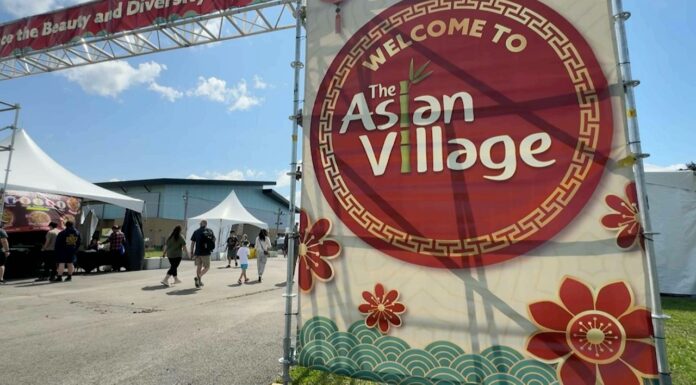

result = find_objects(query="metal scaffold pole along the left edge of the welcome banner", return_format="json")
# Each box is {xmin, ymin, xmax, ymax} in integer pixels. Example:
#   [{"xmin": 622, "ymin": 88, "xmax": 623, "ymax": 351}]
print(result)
[{"xmin": 280, "ymin": 0, "xmax": 304, "ymax": 385}]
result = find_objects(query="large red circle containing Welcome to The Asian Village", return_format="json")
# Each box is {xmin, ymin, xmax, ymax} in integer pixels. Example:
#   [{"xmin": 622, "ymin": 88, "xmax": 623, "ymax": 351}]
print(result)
[{"xmin": 310, "ymin": 0, "xmax": 613, "ymax": 268}]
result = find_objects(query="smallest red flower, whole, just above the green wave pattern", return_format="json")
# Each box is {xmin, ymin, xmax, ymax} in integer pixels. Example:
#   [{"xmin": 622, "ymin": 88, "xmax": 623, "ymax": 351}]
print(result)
[{"xmin": 358, "ymin": 283, "xmax": 406, "ymax": 334}]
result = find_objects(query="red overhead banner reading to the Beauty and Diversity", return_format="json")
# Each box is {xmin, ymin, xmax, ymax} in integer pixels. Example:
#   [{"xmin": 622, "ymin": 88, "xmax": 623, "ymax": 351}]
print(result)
[{"xmin": 0, "ymin": 0, "xmax": 258, "ymax": 58}]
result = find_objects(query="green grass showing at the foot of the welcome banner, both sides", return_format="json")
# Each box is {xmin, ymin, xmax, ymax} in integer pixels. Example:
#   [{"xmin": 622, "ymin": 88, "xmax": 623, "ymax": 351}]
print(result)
[{"xmin": 291, "ymin": 297, "xmax": 696, "ymax": 385}]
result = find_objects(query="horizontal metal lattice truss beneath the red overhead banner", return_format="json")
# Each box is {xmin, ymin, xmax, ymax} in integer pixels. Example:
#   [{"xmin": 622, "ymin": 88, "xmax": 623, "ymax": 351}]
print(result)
[{"xmin": 0, "ymin": 0, "xmax": 297, "ymax": 81}]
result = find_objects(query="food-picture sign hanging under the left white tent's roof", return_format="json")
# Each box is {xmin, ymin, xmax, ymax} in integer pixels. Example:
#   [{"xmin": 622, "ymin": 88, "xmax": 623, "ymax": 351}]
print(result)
[{"xmin": 2, "ymin": 191, "xmax": 82, "ymax": 233}]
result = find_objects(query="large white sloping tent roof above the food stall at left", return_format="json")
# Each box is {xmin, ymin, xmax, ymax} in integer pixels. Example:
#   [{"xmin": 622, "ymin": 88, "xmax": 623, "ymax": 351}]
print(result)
[{"xmin": 0, "ymin": 129, "xmax": 144, "ymax": 212}]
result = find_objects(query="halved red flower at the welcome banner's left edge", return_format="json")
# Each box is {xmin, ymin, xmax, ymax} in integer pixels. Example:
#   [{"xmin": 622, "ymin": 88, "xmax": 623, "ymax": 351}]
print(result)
[{"xmin": 297, "ymin": 211, "xmax": 341, "ymax": 292}]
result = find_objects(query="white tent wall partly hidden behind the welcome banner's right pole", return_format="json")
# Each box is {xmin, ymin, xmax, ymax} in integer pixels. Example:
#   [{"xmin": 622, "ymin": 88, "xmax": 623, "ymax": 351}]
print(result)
[{"xmin": 645, "ymin": 171, "xmax": 696, "ymax": 295}]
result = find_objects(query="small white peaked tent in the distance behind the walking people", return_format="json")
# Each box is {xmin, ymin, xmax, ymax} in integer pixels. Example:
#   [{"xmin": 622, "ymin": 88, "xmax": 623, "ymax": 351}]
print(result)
[{"xmin": 186, "ymin": 191, "xmax": 268, "ymax": 252}]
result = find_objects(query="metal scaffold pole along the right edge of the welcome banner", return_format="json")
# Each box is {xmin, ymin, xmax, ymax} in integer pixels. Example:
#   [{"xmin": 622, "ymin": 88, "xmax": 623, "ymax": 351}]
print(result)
[{"xmin": 612, "ymin": 0, "xmax": 672, "ymax": 385}]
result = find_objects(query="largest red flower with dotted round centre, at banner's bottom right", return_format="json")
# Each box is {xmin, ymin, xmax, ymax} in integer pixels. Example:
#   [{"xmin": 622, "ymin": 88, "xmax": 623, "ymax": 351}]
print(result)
[{"xmin": 527, "ymin": 277, "xmax": 657, "ymax": 385}]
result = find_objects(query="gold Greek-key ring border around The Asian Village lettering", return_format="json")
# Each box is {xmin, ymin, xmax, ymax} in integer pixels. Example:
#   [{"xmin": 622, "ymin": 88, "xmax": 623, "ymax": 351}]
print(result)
[{"xmin": 318, "ymin": 0, "xmax": 600, "ymax": 257}]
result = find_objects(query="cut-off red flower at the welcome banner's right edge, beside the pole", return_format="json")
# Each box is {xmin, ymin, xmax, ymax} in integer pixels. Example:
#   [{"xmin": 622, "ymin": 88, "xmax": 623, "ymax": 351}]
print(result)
[{"xmin": 602, "ymin": 182, "xmax": 645, "ymax": 249}]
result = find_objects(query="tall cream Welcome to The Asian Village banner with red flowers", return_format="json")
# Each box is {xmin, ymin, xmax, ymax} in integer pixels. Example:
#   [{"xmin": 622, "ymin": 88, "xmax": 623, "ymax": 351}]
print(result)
[{"xmin": 297, "ymin": 0, "xmax": 657, "ymax": 385}]
